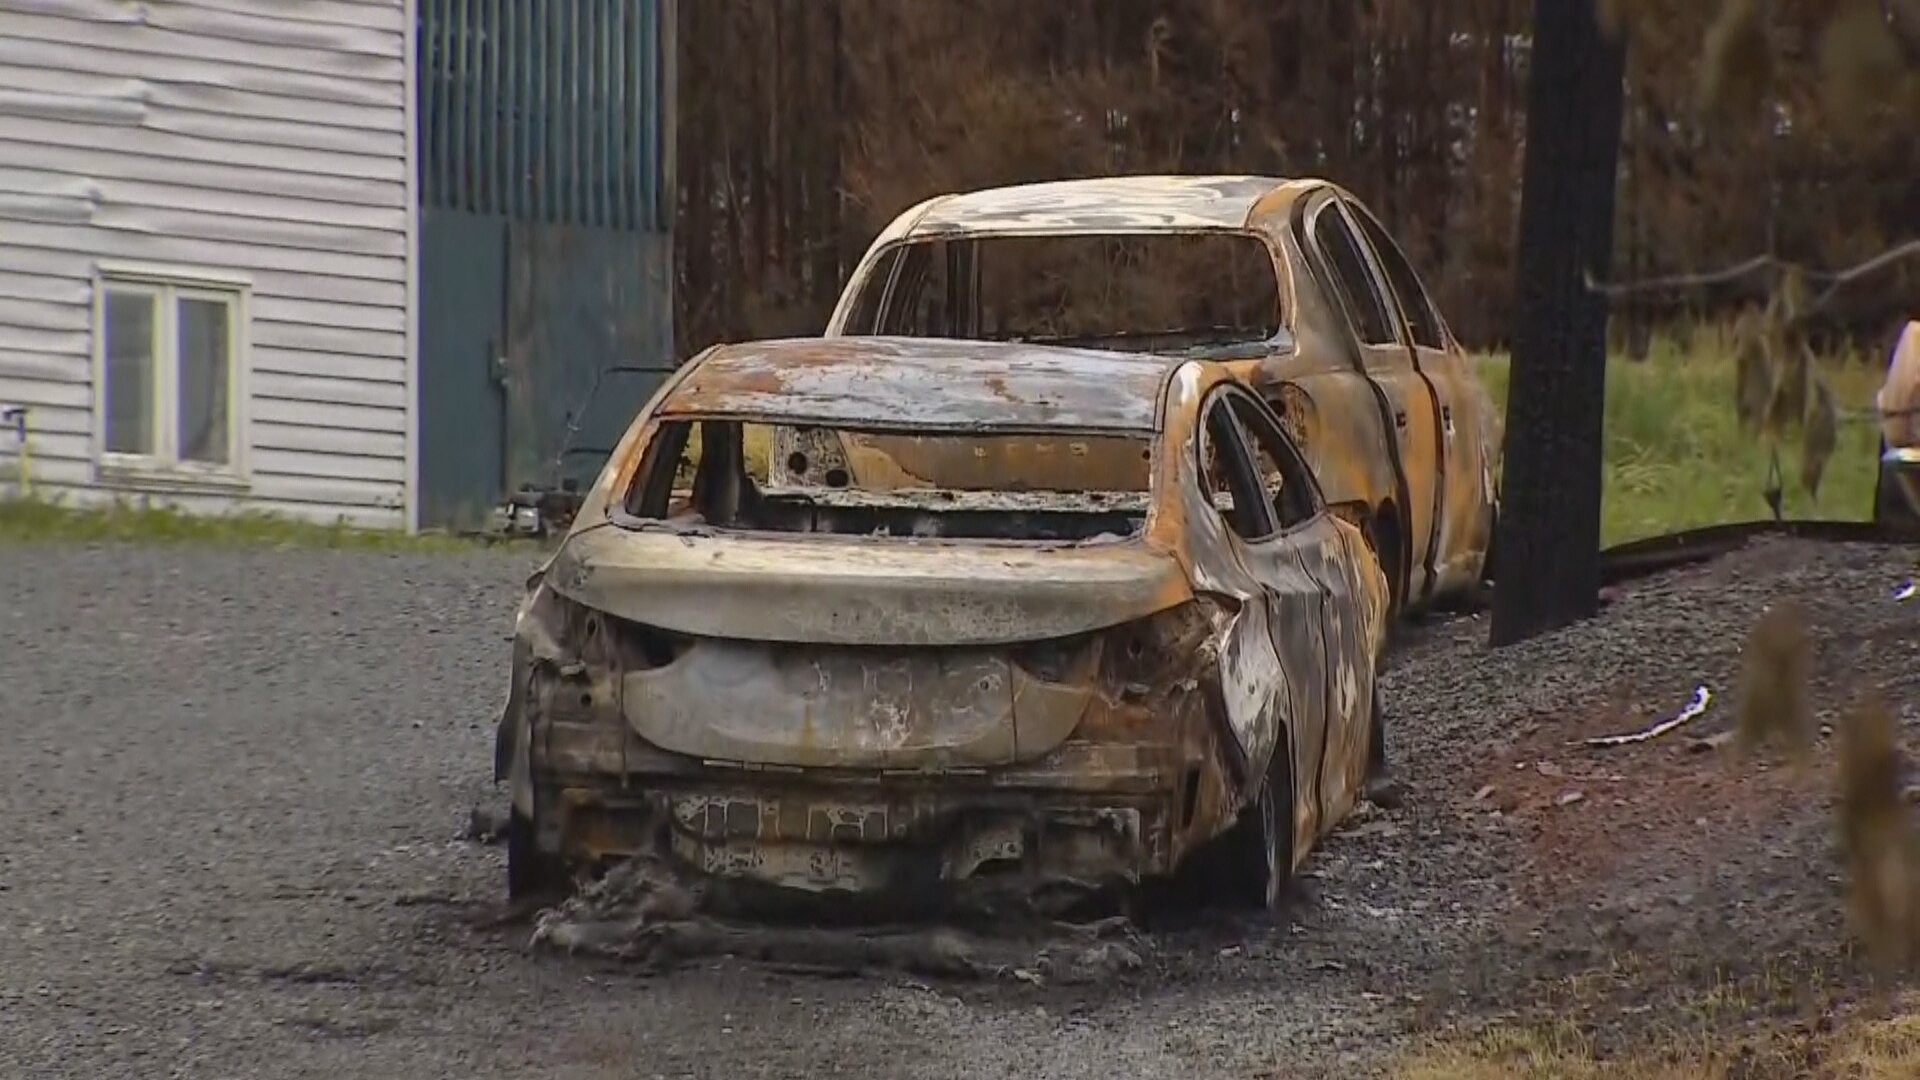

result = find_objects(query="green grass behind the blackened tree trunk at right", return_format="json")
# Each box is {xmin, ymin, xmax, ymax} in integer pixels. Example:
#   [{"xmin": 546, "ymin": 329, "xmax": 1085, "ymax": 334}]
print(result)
[{"xmin": 1478, "ymin": 332, "xmax": 1884, "ymax": 544}]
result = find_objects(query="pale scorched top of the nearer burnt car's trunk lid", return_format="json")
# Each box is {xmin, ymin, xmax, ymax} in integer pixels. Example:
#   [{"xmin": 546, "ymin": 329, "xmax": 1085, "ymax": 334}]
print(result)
[{"xmin": 545, "ymin": 525, "xmax": 1192, "ymax": 646}]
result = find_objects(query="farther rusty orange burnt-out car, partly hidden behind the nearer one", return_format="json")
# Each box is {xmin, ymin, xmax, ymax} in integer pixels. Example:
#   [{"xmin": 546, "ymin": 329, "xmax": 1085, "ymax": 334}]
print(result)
[{"xmin": 770, "ymin": 177, "xmax": 1500, "ymax": 609}]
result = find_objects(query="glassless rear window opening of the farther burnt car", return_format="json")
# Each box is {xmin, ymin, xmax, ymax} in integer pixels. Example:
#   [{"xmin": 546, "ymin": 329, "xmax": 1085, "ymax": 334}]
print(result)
[{"xmin": 845, "ymin": 233, "xmax": 1284, "ymax": 356}]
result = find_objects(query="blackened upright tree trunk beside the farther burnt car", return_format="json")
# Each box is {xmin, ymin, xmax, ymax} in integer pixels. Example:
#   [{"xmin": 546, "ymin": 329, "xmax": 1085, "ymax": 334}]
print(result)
[{"xmin": 1492, "ymin": 0, "xmax": 1626, "ymax": 646}]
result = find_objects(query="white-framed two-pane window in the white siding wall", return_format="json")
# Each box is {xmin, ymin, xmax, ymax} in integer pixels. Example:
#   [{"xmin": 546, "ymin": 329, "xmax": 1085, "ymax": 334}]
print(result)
[{"xmin": 94, "ymin": 265, "xmax": 250, "ymax": 486}]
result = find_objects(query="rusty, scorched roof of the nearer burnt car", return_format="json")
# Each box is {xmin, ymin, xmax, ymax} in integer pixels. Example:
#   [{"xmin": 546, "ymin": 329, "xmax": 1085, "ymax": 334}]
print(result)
[{"xmin": 657, "ymin": 336, "xmax": 1181, "ymax": 434}]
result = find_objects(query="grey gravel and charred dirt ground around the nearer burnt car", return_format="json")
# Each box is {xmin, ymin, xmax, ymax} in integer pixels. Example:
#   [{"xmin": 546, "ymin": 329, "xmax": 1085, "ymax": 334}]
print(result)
[{"xmin": 0, "ymin": 544, "xmax": 1920, "ymax": 1078}]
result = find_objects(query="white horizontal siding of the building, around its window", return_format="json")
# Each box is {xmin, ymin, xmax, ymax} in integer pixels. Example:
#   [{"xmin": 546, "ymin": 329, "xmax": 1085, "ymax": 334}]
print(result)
[{"xmin": 0, "ymin": 0, "xmax": 415, "ymax": 527}]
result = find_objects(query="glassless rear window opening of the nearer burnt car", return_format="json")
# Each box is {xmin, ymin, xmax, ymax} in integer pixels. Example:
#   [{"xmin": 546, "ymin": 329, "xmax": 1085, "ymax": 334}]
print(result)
[{"xmin": 626, "ymin": 419, "xmax": 1152, "ymax": 544}]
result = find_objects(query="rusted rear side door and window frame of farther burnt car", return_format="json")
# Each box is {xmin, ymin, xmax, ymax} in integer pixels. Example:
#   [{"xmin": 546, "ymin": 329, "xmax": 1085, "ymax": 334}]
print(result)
[{"xmin": 1296, "ymin": 184, "xmax": 1446, "ymax": 603}]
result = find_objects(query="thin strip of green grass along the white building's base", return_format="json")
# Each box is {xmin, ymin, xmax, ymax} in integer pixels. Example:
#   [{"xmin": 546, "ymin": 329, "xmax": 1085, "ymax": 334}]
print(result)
[{"xmin": 0, "ymin": 498, "xmax": 495, "ymax": 552}]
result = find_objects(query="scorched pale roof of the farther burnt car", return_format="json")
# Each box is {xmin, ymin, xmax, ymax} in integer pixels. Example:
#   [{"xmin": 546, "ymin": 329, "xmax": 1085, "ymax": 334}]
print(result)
[{"xmin": 908, "ymin": 175, "xmax": 1292, "ymax": 236}]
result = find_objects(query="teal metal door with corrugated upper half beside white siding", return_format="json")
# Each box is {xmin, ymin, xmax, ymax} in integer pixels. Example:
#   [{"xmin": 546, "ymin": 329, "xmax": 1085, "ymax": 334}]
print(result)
[{"xmin": 420, "ymin": 0, "xmax": 674, "ymax": 525}]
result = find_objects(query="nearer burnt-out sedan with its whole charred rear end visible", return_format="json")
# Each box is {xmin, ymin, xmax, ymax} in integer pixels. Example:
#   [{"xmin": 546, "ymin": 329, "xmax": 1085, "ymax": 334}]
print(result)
[{"xmin": 495, "ymin": 336, "xmax": 1388, "ymax": 903}]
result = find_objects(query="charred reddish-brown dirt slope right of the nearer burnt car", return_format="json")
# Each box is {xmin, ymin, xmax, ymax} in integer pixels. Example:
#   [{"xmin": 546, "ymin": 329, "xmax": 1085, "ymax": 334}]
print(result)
[{"xmin": 1404, "ymin": 542, "xmax": 1920, "ymax": 1074}]
